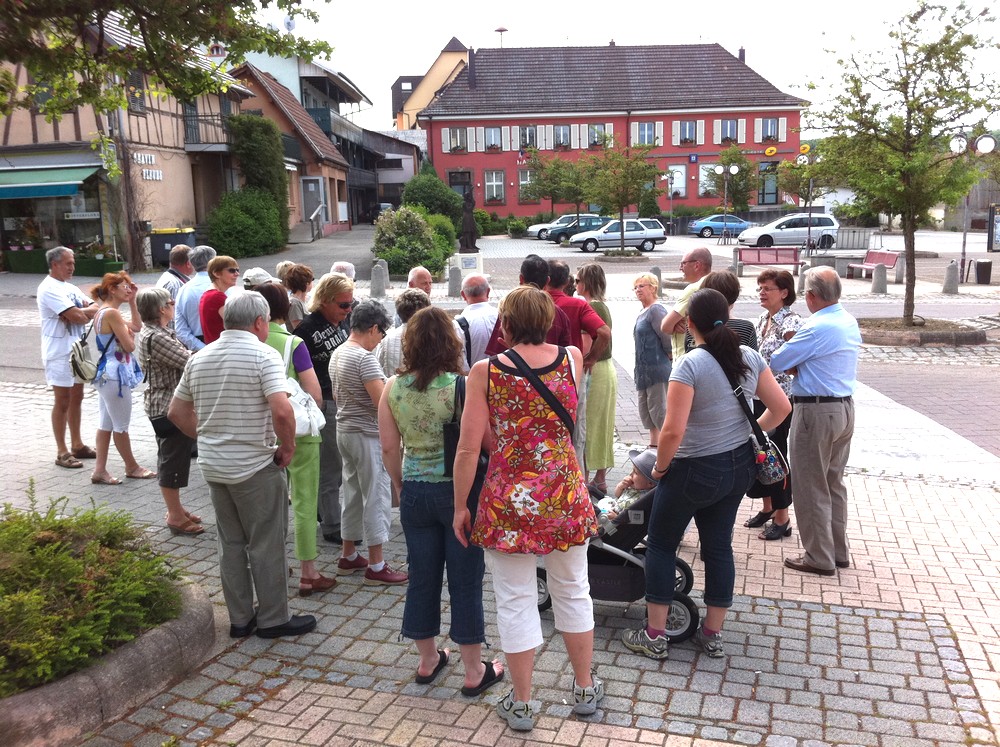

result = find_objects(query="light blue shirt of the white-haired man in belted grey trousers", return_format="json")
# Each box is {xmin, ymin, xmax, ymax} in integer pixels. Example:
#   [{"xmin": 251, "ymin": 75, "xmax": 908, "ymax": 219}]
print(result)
[{"xmin": 771, "ymin": 303, "xmax": 861, "ymax": 397}]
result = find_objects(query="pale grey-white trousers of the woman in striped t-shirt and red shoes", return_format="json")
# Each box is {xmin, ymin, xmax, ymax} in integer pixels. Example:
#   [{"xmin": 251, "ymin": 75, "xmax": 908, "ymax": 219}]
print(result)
[{"xmin": 337, "ymin": 429, "xmax": 392, "ymax": 546}]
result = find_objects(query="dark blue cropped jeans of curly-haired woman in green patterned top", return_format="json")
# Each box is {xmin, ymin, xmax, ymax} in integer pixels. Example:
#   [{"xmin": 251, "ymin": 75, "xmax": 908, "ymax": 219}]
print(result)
[{"xmin": 399, "ymin": 480, "xmax": 486, "ymax": 646}]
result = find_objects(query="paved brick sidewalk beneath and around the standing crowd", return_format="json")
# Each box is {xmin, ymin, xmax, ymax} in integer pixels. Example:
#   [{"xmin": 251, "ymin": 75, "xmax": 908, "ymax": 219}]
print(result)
[{"xmin": 0, "ymin": 241, "xmax": 1000, "ymax": 747}]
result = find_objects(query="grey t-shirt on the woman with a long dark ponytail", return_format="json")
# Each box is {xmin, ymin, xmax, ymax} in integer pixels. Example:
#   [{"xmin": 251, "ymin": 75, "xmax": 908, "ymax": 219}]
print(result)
[{"xmin": 670, "ymin": 345, "xmax": 767, "ymax": 459}]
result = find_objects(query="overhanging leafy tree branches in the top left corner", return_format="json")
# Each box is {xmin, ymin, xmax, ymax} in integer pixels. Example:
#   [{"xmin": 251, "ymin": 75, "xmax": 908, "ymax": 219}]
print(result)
[{"xmin": 0, "ymin": 0, "xmax": 332, "ymax": 119}]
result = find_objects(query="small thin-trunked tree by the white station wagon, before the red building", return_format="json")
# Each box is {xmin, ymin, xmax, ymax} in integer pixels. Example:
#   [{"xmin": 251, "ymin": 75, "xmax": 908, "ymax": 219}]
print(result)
[{"xmin": 582, "ymin": 138, "xmax": 662, "ymax": 251}]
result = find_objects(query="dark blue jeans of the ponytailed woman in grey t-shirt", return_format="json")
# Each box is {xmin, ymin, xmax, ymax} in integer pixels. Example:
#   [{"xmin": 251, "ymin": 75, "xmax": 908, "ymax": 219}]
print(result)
[{"xmin": 646, "ymin": 442, "xmax": 757, "ymax": 607}]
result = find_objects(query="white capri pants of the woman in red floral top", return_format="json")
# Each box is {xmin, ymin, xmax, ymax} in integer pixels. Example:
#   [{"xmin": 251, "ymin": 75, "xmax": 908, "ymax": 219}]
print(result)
[{"xmin": 486, "ymin": 542, "xmax": 594, "ymax": 654}]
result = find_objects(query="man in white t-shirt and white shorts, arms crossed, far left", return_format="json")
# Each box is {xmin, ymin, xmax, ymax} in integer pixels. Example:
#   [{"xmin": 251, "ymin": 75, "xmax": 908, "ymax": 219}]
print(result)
[{"xmin": 35, "ymin": 246, "xmax": 97, "ymax": 469}]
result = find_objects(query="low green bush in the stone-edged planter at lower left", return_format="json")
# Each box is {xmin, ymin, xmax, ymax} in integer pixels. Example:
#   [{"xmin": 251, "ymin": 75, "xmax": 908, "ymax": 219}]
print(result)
[{"xmin": 0, "ymin": 482, "xmax": 181, "ymax": 697}]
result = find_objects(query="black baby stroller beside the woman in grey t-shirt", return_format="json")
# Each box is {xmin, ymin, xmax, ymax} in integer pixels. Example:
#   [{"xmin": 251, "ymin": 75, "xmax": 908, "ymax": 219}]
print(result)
[{"xmin": 537, "ymin": 487, "xmax": 700, "ymax": 643}]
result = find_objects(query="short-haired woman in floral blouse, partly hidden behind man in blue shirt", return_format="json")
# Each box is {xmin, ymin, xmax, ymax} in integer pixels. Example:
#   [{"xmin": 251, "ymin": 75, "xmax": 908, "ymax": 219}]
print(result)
[{"xmin": 744, "ymin": 269, "xmax": 802, "ymax": 540}]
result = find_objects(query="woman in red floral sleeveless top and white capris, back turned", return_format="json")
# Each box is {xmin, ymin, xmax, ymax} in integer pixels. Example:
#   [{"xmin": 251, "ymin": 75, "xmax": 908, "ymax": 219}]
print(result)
[{"xmin": 454, "ymin": 286, "xmax": 604, "ymax": 731}]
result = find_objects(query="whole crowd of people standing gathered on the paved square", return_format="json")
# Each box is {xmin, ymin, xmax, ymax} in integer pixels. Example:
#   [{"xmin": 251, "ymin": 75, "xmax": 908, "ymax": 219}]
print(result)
[{"xmin": 39, "ymin": 246, "xmax": 860, "ymax": 730}]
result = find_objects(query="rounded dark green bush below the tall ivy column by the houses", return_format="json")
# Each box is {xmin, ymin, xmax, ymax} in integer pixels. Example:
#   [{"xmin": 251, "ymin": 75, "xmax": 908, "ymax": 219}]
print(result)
[{"xmin": 206, "ymin": 187, "xmax": 285, "ymax": 258}]
